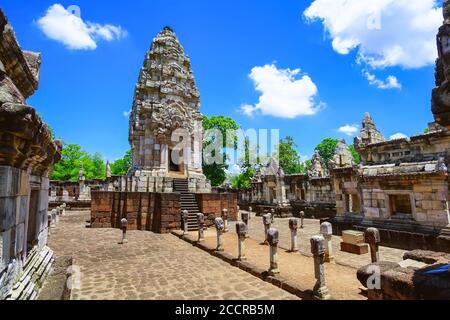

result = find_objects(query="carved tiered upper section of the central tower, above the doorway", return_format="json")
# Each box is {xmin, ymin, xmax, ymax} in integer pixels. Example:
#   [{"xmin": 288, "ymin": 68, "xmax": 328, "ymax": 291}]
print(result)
[{"xmin": 129, "ymin": 27, "xmax": 202, "ymax": 144}]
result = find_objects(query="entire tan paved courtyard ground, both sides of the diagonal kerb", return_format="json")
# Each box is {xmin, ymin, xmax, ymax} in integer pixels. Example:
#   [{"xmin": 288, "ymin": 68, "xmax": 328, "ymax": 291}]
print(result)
[{"xmin": 43, "ymin": 211, "xmax": 404, "ymax": 300}]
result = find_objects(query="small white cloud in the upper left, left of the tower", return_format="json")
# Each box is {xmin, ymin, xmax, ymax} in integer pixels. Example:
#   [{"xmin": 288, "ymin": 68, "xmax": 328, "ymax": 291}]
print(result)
[{"xmin": 37, "ymin": 3, "xmax": 127, "ymax": 50}]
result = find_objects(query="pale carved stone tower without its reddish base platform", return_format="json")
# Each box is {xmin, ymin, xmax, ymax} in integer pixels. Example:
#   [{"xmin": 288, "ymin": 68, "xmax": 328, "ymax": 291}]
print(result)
[{"xmin": 129, "ymin": 27, "xmax": 211, "ymax": 192}]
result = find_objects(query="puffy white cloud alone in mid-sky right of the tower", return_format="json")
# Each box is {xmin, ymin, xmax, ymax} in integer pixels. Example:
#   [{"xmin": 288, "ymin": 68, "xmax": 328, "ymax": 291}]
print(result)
[{"xmin": 241, "ymin": 64, "xmax": 323, "ymax": 119}]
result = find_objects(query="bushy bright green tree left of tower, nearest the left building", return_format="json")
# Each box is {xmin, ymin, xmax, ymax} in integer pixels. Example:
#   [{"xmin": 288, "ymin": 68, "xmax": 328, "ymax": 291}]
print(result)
[{"xmin": 52, "ymin": 144, "xmax": 106, "ymax": 181}]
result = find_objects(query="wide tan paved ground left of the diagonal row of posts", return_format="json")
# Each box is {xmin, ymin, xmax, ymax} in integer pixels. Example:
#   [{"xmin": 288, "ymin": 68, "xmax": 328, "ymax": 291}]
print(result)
[{"xmin": 49, "ymin": 211, "xmax": 297, "ymax": 300}]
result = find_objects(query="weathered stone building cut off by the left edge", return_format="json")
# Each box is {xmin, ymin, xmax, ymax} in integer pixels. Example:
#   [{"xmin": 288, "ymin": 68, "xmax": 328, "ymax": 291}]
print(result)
[{"xmin": 0, "ymin": 10, "xmax": 61, "ymax": 300}]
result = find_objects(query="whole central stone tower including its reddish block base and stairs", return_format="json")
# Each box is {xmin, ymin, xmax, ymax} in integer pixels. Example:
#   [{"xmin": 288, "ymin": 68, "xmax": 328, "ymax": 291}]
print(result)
[{"xmin": 91, "ymin": 27, "xmax": 238, "ymax": 233}]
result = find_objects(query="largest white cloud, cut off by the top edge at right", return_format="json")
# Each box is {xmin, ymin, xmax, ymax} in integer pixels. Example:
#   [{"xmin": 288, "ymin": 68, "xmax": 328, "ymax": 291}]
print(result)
[{"xmin": 304, "ymin": 0, "xmax": 442, "ymax": 68}]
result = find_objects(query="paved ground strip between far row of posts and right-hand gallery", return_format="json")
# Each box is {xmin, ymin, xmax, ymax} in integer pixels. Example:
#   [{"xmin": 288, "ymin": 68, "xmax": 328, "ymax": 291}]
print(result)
[{"xmin": 230, "ymin": 217, "xmax": 406, "ymax": 269}]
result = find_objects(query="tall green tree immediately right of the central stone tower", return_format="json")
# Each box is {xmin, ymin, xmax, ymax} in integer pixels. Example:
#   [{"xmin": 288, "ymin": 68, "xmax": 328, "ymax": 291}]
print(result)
[{"xmin": 203, "ymin": 116, "xmax": 239, "ymax": 186}]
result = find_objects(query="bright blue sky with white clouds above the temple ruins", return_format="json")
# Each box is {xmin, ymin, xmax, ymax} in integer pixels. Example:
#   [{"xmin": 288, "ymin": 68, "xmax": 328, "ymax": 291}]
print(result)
[{"xmin": 1, "ymin": 0, "xmax": 442, "ymax": 160}]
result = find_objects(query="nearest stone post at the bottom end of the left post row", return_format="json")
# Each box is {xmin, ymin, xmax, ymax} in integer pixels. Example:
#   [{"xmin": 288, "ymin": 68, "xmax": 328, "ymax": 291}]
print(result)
[{"xmin": 311, "ymin": 235, "xmax": 330, "ymax": 300}]
